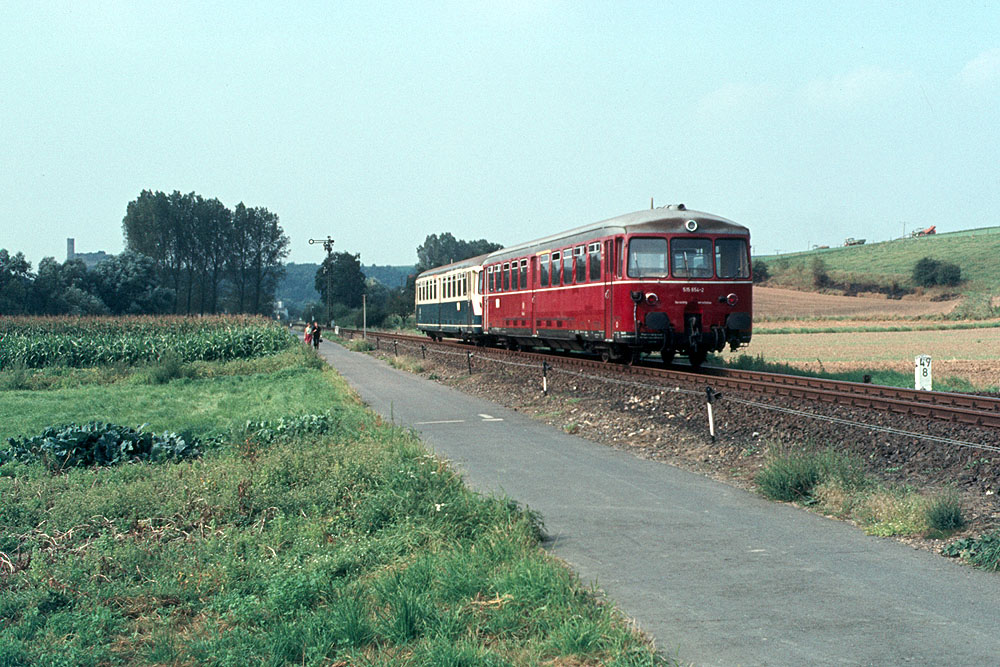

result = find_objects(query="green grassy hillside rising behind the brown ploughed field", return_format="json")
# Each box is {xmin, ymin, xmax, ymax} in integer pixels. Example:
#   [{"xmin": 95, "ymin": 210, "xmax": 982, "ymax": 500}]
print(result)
[{"xmin": 754, "ymin": 227, "xmax": 1000, "ymax": 317}]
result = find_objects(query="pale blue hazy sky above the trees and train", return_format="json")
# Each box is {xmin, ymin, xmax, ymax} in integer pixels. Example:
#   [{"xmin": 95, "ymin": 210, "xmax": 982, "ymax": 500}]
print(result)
[{"xmin": 0, "ymin": 0, "xmax": 1000, "ymax": 268}]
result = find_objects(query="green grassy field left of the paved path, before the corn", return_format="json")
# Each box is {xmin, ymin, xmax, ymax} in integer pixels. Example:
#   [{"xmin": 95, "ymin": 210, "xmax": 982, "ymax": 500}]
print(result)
[{"xmin": 0, "ymin": 320, "xmax": 665, "ymax": 666}]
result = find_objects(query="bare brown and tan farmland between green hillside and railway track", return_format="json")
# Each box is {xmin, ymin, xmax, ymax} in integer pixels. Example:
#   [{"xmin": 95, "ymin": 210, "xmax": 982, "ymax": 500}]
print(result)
[{"xmin": 724, "ymin": 287, "xmax": 1000, "ymax": 389}]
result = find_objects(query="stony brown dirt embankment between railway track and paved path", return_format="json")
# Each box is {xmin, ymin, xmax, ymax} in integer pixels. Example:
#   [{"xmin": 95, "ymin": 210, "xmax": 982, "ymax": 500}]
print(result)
[{"xmin": 373, "ymin": 345, "xmax": 1000, "ymax": 552}]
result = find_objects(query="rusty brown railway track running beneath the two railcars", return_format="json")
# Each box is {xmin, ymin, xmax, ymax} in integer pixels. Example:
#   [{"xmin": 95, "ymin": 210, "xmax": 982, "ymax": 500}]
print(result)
[{"xmin": 341, "ymin": 329, "xmax": 1000, "ymax": 428}]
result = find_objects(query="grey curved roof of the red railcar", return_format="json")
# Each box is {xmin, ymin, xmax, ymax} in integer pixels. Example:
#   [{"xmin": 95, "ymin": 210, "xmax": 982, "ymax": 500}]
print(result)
[{"xmin": 485, "ymin": 206, "xmax": 750, "ymax": 263}]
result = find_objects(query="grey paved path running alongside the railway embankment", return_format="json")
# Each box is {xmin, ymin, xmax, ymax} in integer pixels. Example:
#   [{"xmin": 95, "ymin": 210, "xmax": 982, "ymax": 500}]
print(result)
[{"xmin": 320, "ymin": 342, "xmax": 1000, "ymax": 666}]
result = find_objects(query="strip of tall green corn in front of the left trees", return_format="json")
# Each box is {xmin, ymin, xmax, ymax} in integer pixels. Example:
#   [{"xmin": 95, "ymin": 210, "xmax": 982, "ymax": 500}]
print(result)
[{"xmin": 0, "ymin": 316, "xmax": 295, "ymax": 369}]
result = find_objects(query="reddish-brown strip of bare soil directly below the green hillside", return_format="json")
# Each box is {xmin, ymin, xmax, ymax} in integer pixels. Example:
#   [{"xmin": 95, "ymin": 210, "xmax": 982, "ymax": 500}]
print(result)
[{"xmin": 753, "ymin": 286, "xmax": 959, "ymax": 321}]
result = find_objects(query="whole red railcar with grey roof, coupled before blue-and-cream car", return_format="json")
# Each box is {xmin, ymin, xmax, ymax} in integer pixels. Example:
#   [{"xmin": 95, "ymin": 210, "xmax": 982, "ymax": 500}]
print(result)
[{"xmin": 480, "ymin": 205, "xmax": 753, "ymax": 364}]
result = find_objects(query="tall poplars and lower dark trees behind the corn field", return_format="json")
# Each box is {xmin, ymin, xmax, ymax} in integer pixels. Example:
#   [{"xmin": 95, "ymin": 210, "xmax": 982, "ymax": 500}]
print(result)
[{"xmin": 0, "ymin": 190, "xmax": 289, "ymax": 315}]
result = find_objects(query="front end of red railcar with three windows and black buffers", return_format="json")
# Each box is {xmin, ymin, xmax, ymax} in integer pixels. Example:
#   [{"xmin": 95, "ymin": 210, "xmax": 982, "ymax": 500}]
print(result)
[{"xmin": 613, "ymin": 207, "xmax": 753, "ymax": 365}]
